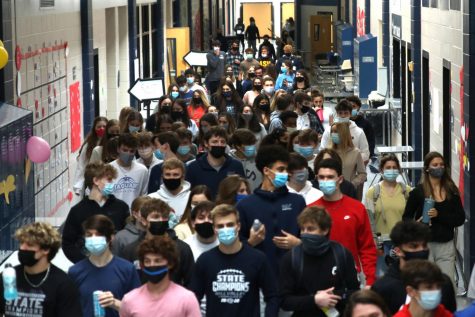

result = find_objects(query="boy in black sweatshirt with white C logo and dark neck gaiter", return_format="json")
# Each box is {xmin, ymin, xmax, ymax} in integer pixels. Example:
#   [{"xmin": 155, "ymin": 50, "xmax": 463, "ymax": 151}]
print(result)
[{"xmin": 279, "ymin": 207, "xmax": 359, "ymax": 317}]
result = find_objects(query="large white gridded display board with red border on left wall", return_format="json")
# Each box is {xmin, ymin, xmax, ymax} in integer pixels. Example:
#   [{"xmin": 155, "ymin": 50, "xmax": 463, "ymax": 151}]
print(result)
[{"xmin": 15, "ymin": 40, "xmax": 72, "ymax": 219}]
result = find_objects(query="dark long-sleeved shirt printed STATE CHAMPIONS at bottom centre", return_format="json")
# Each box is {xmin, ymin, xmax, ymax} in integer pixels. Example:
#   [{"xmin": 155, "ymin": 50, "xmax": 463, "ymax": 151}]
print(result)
[{"xmin": 190, "ymin": 244, "xmax": 279, "ymax": 317}]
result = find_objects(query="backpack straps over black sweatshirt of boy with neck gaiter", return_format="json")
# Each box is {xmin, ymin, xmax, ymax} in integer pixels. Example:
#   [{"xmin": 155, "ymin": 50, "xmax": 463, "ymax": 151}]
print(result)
[{"xmin": 290, "ymin": 241, "xmax": 348, "ymax": 294}]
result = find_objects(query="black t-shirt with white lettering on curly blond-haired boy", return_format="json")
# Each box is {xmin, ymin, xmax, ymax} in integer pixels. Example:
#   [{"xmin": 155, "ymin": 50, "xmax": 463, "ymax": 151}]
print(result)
[{"xmin": 0, "ymin": 264, "xmax": 82, "ymax": 317}]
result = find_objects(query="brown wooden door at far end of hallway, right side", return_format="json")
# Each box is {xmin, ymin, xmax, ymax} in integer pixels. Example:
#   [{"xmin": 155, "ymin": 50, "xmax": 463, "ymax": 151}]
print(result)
[{"xmin": 308, "ymin": 15, "xmax": 332, "ymax": 55}]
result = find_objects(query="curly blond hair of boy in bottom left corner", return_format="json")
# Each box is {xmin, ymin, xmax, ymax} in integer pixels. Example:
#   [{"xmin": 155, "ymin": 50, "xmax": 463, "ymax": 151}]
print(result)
[{"xmin": 15, "ymin": 222, "xmax": 61, "ymax": 261}]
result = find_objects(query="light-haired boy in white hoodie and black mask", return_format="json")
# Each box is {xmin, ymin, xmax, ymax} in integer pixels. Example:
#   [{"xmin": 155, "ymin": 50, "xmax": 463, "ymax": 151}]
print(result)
[{"xmin": 149, "ymin": 158, "xmax": 190, "ymax": 221}]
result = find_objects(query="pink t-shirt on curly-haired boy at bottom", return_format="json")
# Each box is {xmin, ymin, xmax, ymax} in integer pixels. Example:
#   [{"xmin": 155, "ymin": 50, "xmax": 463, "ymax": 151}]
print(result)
[{"xmin": 120, "ymin": 282, "xmax": 201, "ymax": 317}]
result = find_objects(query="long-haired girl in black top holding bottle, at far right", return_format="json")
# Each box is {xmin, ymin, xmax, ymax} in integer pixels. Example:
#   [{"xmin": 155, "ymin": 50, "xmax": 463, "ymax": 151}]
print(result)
[{"xmin": 403, "ymin": 152, "xmax": 465, "ymax": 281}]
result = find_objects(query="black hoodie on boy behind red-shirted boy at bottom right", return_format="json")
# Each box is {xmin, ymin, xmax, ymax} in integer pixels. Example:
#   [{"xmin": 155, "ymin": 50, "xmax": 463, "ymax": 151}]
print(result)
[{"xmin": 371, "ymin": 261, "xmax": 457, "ymax": 314}]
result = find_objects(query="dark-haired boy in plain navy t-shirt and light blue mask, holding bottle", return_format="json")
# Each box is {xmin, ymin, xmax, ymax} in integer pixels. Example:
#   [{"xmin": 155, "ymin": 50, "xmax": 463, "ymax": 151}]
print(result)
[{"xmin": 68, "ymin": 215, "xmax": 140, "ymax": 317}]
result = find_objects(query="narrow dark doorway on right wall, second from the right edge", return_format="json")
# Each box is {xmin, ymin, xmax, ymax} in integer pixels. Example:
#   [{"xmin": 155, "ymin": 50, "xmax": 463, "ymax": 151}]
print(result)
[{"xmin": 422, "ymin": 51, "xmax": 430, "ymax": 155}]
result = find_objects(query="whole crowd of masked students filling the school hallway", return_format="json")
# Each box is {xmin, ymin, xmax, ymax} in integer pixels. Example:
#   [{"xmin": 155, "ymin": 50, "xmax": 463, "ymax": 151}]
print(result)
[{"xmin": 0, "ymin": 34, "xmax": 472, "ymax": 317}]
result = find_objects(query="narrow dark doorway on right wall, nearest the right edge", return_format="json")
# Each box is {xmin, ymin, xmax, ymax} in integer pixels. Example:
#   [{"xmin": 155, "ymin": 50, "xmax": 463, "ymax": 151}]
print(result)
[{"xmin": 442, "ymin": 59, "xmax": 452, "ymax": 166}]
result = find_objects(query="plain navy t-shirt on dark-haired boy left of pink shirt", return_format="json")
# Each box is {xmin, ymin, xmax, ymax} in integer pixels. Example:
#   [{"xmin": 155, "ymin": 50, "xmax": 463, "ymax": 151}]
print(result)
[{"xmin": 68, "ymin": 256, "xmax": 141, "ymax": 317}]
